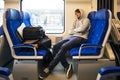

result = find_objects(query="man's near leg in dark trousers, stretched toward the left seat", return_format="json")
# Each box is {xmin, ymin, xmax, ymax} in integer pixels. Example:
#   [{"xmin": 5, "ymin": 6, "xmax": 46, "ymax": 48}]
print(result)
[{"xmin": 48, "ymin": 37, "xmax": 86, "ymax": 70}]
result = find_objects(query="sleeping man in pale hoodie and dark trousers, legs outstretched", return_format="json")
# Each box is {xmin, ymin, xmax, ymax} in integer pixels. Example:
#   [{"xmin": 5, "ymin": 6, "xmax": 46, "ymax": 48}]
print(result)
[{"xmin": 39, "ymin": 9, "xmax": 90, "ymax": 79}]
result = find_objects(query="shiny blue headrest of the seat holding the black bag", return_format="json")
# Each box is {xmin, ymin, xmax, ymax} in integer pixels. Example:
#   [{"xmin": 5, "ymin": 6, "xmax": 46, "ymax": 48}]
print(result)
[{"xmin": 6, "ymin": 8, "xmax": 22, "ymax": 20}]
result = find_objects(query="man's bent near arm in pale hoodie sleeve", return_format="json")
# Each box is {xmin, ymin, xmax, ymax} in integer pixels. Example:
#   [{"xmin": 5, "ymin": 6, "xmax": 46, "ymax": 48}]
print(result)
[{"xmin": 74, "ymin": 19, "xmax": 90, "ymax": 33}]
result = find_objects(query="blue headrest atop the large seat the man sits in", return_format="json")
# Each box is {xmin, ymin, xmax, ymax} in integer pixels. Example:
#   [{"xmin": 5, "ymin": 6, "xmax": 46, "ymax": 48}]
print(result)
[{"xmin": 95, "ymin": 9, "xmax": 109, "ymax": 20}]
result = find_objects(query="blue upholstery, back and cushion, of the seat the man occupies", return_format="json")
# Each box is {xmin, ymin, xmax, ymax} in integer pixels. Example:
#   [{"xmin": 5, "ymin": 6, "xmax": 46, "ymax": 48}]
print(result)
[{"xmin": 70, "ymin": 9, "xmax": 109, "ymax": 57}]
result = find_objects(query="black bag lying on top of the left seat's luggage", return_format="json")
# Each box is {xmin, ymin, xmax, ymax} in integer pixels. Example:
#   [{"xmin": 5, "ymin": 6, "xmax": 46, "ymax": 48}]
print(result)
[{"xmin": 23, "ymin": 26, "xmax": 45, "ymax": 40}]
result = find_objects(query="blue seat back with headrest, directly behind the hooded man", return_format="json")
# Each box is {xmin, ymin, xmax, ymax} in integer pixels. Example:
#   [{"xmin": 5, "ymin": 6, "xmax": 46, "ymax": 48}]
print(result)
[{"xmin": 88, "ymin": 9, "xmax": 109, "ymax": 45}]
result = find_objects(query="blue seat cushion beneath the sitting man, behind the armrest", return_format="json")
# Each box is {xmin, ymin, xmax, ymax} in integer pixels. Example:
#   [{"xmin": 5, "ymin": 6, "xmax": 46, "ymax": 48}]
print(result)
[{"xmin": 70, "ymin": 47, "xmax": 100, "ymax": 57}]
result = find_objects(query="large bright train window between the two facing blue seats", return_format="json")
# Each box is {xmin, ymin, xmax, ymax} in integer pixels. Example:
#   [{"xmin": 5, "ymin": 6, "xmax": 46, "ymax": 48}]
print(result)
[{"xmin": 22, "ymin": 0, "xmax": 65, "ymax": 33}]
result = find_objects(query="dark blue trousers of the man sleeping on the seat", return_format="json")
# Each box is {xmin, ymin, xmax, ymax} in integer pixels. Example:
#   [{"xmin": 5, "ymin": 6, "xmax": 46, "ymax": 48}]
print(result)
[{"xmin": 48, "ymin": 36, "xmax": 86, "ymax": 70}]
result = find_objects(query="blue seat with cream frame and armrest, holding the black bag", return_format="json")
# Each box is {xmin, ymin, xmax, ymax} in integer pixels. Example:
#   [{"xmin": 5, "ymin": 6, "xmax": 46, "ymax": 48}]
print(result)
[{"xmin": 3, "ymin": 9, "xmax": 46, "ymax": 59}]
